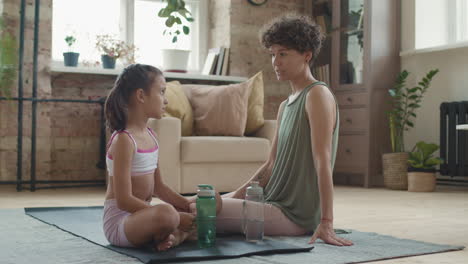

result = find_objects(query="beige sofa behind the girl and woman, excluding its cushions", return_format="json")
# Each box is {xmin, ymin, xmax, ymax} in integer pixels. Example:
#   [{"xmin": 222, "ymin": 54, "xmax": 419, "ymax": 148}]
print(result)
[{"xmin": 148, "ymin": 117, "xmax": 276, "ymax": 193}]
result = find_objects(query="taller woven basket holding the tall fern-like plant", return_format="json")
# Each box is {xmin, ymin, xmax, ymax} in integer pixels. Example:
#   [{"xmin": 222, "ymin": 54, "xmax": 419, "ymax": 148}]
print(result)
[{"xmin": 382, "ymin": 152, "xmax": 409, "ymax": 190}]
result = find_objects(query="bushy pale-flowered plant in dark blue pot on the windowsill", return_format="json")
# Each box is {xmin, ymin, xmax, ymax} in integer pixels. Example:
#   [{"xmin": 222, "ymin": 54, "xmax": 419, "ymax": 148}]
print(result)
[{"xmin": 96, "ymin": 34, "xmax": 136, "ymax": 69}]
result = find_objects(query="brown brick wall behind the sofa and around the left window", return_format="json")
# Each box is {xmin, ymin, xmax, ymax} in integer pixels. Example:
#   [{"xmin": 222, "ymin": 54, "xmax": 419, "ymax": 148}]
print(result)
[{"xmin": 0, "ymin": 0, "xmax": 304, "ymax": 184}]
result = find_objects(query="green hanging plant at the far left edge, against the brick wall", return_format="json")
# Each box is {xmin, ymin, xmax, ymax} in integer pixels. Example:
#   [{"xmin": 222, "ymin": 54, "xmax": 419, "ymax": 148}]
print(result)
[{"xmin": 0, "ymin": 17, "xmax": 18, "ymax": 98}]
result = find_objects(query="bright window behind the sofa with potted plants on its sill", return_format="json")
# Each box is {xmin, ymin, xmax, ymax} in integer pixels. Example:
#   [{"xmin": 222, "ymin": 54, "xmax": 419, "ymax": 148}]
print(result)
[{"xmin": 52, "ymin": 0, "xmax": 207, "ymax": 71}]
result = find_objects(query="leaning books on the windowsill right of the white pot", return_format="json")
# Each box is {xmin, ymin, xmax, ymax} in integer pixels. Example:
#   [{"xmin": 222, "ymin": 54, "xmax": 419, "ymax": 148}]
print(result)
[{"xmin": 201, "ymin": 47, "xmax": 229, "ymax": 75}]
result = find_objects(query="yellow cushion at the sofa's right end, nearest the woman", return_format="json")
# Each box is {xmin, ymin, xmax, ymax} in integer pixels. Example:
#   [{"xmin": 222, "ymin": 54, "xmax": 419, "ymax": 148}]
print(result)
[{"xmin": 245, "ymin": 72, "xmax": 265, "ymax": 135}]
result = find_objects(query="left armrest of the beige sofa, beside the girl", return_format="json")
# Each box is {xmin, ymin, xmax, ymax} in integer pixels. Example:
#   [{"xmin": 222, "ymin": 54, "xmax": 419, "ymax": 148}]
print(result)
[{"xmin": 148, "ymin": 117, "xmax": 182, "ymax": 192}]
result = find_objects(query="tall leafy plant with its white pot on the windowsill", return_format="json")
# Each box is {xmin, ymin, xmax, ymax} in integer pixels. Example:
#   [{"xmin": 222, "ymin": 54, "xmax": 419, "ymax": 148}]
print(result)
[{"xmin": 158, "ymin": 0, "xmax": 194, "ymax": 72}]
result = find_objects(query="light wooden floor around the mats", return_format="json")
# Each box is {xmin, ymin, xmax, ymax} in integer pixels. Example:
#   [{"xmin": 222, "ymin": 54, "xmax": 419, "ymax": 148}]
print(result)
[{"xmin": 0, "ymin": 186, "xmax": 468, "ymax": 263}]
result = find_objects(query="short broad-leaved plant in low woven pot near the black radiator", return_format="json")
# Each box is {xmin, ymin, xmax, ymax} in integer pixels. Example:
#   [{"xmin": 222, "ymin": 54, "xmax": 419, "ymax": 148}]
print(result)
[{"xmin": 408, "ymin": 141, "xmax": 442, "ymax": 192}]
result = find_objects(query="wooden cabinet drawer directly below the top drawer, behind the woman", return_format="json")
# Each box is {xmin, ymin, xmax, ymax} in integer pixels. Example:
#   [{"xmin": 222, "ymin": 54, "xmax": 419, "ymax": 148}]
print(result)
[{"xmin": 335, "ymin": 135, "xmax": 367, "ymax": 170}]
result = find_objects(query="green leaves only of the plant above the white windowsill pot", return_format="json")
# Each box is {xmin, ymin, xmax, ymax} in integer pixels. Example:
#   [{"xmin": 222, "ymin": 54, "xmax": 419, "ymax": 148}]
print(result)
[{"xmin": 158, "ymin": 0, "xmax": 194, "ymax": 43}]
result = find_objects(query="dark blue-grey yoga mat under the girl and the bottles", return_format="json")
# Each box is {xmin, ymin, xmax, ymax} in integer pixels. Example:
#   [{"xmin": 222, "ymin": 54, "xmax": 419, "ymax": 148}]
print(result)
[{"xmin": 25, "ymin": 206, "xmax": 313, "ymax": 263}]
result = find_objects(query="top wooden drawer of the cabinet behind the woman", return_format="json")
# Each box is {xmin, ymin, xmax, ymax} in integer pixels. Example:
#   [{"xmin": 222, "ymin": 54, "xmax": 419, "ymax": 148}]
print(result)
[{"xmin": 340, "ymin": 108, "xmax": 368, "ymax": 132}]
